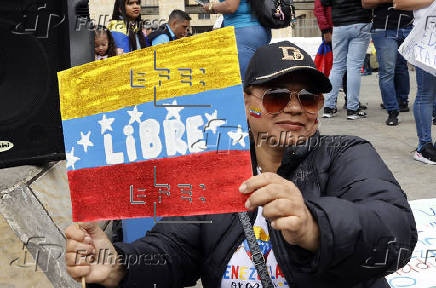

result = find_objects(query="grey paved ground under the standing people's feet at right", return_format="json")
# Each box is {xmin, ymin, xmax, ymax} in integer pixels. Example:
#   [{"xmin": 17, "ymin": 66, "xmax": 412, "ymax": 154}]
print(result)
[{"xmin": 320, "ymin": 72, "xmax": 436, "ymax": 200}]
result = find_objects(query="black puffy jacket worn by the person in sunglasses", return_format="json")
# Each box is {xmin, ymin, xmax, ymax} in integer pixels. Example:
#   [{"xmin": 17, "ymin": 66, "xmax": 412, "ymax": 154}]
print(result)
[{"xmin": 91, "ymin": 134, "xmax": 417, "ymax": 288}]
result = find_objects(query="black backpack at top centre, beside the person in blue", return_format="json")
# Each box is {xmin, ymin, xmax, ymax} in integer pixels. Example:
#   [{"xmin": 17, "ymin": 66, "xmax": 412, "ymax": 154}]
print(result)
[{"xmin": 249, "ymin": 0, "xmax": 295, "ymax": 29}]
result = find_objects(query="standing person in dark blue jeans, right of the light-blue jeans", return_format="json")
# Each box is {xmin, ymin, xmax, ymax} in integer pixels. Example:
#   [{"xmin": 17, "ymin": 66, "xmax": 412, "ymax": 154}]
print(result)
[{"xmin": 362, "ymin": 0, "xmax": 413, "ymax": 126}]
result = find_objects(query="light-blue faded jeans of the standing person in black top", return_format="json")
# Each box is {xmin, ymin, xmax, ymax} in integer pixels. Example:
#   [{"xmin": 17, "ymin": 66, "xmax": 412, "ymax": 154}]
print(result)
[{"xmin": 324, "ymin": 23, "xmax": 371, "ymax": 111}]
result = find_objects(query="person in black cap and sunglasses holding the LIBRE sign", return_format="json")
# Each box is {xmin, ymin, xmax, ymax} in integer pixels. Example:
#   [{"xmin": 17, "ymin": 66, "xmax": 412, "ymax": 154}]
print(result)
[{"xmin": 66, "ymin": 42, "xmax": 417, "ymax": 288}]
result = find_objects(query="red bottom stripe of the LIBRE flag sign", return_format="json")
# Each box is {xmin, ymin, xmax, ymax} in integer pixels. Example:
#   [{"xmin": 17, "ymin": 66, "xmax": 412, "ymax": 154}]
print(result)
[{"xmin": 68, "ymin": 150, "xmax": 252, "ymax": 222}]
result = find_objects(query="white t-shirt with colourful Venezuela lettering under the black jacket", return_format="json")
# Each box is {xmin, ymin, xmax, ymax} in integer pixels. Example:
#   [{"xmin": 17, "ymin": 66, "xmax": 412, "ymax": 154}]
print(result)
[{"xmin": 221, "ymin": 207, "xmax": 289, "ymax": 288}]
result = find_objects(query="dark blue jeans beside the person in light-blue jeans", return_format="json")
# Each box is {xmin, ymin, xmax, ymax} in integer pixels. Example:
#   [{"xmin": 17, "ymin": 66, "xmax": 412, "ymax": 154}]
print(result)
[{"xmin": 371, "ymin": 27, "xmax": 412, "ymax": 112}]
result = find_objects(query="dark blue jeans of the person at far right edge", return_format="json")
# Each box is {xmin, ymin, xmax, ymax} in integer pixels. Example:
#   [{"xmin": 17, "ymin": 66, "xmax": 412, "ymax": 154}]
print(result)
[{"xmin": 413, "ymin": 67, "xmax": 436, "ymax": 150}]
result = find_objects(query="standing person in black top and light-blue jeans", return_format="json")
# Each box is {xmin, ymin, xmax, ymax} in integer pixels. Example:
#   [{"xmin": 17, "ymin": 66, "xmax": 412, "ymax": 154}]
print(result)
[{"xmin": 323, "ymin": 0, "xmax": 371, "ymax": 120}]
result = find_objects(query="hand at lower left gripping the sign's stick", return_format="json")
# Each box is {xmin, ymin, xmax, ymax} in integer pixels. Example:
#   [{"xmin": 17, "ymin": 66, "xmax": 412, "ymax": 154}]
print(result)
[{"xmin": 65, "ymin": 222, "xmax": 125, "ymax": 287}]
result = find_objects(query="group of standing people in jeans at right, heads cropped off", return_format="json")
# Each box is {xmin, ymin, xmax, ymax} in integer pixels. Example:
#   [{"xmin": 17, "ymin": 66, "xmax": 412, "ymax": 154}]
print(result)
[{"xmin": 314, "ymin": 0, "xmax": 436, "ymax": 164}]
